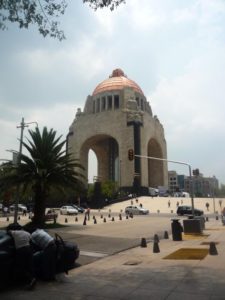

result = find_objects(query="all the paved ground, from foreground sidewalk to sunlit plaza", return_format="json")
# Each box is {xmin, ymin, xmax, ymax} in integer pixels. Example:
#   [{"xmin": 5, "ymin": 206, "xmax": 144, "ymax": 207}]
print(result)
[{"xmin": 0, "ymin": 197, "xmax": 225, "ymax": 300}]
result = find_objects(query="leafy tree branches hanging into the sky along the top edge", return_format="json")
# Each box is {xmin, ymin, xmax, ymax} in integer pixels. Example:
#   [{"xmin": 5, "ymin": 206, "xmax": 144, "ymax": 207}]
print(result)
[{"xmin": 0, "ymin": 0, "xmax": 125, "ymax": 41}]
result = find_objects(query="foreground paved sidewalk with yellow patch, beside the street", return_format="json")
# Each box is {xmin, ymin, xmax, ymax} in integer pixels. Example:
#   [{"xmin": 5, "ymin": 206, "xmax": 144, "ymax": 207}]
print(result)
[{"xmin": 1, "ymin": 219, "xmax": 225, "ymax": 300}]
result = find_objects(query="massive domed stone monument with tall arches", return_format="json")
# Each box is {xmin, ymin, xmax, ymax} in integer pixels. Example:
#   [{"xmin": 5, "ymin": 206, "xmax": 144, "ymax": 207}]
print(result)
[{"xmin": 68, "ymin": 69, "xmax": 168, "ymax": 193}]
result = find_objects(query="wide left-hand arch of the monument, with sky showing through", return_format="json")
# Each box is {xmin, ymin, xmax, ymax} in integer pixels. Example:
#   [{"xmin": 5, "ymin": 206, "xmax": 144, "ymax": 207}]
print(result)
[{"xmin": 80, "ymin": 134, "xmax": 119, "ymax": 182}]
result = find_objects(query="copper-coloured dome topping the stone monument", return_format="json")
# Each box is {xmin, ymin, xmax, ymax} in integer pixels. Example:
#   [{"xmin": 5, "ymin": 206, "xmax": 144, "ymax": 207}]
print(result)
[{"xmin": 92, "ymin": 69, "xmax": 144, "ymax": 96}]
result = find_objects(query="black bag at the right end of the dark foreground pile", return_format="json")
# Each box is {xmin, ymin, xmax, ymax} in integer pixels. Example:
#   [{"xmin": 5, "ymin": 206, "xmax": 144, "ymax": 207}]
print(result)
[{"xmin": 55, "ymin": 234, "xmax": 80, "ymax": 274}]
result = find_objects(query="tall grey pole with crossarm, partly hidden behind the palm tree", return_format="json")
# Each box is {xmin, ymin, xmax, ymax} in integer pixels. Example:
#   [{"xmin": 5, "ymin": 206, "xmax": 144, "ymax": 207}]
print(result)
[{"xmin": 14, "ymin": 118, "xmax": 38, "ymax": 224}]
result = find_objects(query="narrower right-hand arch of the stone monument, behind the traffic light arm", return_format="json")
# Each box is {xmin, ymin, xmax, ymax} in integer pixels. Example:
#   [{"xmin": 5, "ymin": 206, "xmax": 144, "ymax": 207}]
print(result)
[{"xmin": 148, "ymin": 138, "xmax": 164, "ymax": 188}]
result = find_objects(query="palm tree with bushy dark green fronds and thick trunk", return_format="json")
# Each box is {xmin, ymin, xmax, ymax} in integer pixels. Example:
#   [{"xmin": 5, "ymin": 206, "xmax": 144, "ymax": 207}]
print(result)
[{"xmin": 1, "ymin": 127, "xmax": 83, "ymax": 226}]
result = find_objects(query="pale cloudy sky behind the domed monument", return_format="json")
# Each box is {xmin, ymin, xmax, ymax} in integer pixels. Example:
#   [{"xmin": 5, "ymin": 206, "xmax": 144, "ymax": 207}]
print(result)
[{"xmin": 0, "ymin": 0, "xmax": 225, "ymax": 184}]
